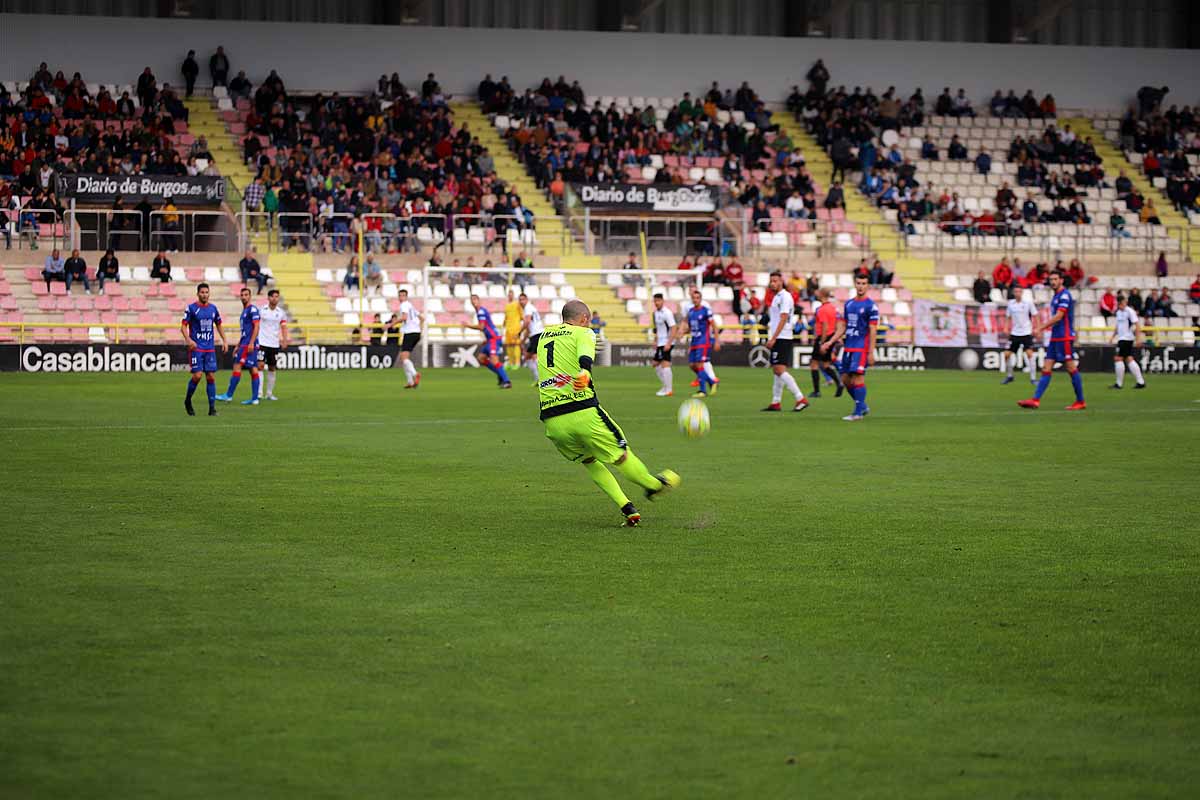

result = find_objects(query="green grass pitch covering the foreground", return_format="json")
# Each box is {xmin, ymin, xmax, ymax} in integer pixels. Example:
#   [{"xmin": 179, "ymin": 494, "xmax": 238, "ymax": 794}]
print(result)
[{"xmin": 0, "ymin": 368, "xmax": 1200, "ymax": 799}]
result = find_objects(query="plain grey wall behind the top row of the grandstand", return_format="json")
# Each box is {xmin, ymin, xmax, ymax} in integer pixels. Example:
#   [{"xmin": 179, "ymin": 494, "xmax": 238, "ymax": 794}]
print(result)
[{"xmin": 7, "ymin": 14, "xmax": 1200, "ymax": 108}]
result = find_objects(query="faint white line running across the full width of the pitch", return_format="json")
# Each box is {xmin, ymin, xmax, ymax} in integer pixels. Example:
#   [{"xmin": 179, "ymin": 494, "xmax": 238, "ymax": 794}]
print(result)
[{"xmin": 0, "ymin": 401, "xmax": 1200, "ymax": 434}]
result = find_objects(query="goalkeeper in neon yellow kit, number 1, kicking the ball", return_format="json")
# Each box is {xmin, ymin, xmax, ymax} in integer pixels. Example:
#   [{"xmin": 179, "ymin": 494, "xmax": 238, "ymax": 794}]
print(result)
[{"xmin": 538, "ymin": 300, "xmax": 679, "ymax": 528}]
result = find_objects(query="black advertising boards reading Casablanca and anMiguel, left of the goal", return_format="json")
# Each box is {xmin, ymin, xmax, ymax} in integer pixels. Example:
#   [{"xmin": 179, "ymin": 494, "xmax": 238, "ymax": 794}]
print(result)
[{"xmin": 0, "ymin": 344, "xmax": 421, "ymax": 372}]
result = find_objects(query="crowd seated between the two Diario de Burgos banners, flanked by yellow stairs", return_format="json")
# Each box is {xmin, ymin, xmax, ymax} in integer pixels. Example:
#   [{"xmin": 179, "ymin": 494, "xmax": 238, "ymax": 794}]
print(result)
[{"xmin": 242, "ymin": 72, "xmax": 536, "ymax": 252}]
